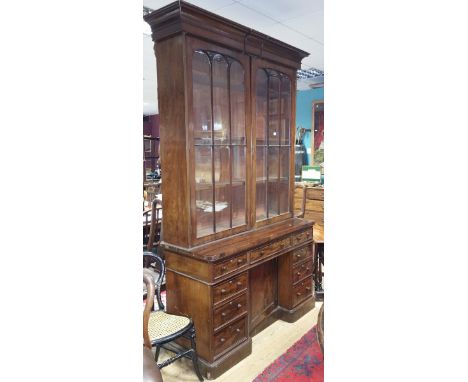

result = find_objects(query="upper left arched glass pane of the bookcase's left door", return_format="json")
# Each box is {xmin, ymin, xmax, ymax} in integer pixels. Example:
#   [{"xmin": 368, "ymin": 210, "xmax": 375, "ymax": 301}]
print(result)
[{"xmin": 192, "ymin": 51, "xmax": 211, "ymax": 144}]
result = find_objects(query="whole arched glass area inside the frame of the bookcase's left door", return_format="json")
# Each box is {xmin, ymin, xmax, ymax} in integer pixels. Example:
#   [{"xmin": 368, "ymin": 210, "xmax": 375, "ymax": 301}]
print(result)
[{"xmin": 192, "ymin": 52, "xmax": 247, "ymax": 237}]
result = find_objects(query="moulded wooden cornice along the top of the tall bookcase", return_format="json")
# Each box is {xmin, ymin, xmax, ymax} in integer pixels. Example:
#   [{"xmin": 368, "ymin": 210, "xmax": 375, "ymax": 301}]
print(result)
[{"xmin": 144, "ymin": 1, "xmax": 309, "ymax": 69}]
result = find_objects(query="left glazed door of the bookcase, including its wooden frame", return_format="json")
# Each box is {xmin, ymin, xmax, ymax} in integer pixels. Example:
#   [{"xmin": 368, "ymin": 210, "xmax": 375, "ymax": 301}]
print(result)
[{"xmin": 187, "ymin": 38, "xmax": 250, "ymax": 244}]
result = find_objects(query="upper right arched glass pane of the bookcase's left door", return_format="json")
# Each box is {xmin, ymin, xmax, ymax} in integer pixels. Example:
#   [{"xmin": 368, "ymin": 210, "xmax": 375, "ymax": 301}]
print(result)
[{"xmin": 230, "ymin": 61, "xmax": 246, "ymax": 144}]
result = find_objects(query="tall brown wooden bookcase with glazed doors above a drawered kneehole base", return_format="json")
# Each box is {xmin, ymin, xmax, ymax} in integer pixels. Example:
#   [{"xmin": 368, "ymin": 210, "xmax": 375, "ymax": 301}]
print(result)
[{"xmin": 145, "ymin": 1, "xmax": 315, "ymax": 379}]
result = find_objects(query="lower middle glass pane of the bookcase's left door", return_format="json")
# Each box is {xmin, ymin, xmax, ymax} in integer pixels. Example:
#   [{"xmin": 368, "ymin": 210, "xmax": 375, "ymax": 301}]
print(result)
[{"xmin": 214, "ymin": 146, "xmax": 231, "ymax": 232}]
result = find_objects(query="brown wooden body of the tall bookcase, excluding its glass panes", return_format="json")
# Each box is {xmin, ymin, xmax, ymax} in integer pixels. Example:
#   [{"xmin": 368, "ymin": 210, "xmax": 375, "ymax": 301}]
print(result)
[{"xmin": 145, "ymin": 1, "xmax": 314, "ymax": 378}]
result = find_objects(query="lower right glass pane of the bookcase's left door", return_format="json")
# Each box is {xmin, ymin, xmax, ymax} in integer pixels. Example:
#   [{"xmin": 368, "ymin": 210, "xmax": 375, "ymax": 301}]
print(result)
[{"xmin": 232, "ymin": 146, "xmax": 246, "ymax": 227}]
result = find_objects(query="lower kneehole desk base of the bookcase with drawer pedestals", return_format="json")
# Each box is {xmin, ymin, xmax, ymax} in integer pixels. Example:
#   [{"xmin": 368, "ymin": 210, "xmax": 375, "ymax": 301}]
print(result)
[{"xmin": 166, "ymin": 222, "xmax": 314, "ymax": 378}]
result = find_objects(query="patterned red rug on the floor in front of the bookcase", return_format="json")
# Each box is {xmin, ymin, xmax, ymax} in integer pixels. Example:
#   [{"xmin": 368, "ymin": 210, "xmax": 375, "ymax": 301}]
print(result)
[{"xmin": 253, "ymin": 326, "xmax": 323, "ymax": 382}]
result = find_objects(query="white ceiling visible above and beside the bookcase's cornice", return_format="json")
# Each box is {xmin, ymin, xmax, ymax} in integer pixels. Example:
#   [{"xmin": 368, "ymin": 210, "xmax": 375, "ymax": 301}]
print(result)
[{"xmin": 143, "ymin": 0, "xmax": 324, "ymax": 115}]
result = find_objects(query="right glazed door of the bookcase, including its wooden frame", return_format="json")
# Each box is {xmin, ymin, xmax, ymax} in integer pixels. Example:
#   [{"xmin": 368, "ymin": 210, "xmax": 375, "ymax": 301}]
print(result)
[{"xmin": 252, "ymin": 59, "xmax": 296, "ymax": 225}]
